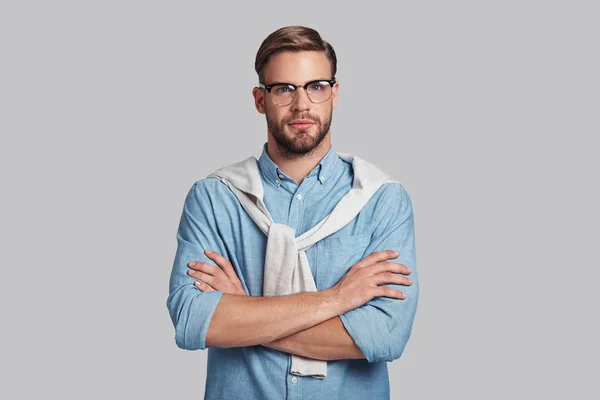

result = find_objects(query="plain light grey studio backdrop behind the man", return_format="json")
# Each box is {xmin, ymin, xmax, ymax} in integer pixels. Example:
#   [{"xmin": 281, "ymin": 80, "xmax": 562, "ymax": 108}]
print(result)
[{"xmin": 0, "ymin": 0, "xmax": 600, "ymax": 399}]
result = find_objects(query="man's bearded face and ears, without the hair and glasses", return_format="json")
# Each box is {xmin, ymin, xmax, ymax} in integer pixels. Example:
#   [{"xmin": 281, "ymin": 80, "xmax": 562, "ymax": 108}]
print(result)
[{"xmin": 253, "ymin": 51, "xmax": 338, "ymax": 154}]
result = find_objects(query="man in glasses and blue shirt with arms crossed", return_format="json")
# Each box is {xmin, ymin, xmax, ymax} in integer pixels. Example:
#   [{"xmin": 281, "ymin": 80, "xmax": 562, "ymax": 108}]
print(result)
[{"xmin": 167, "ymin": 26, "xmax": 418, "ymax": 399}]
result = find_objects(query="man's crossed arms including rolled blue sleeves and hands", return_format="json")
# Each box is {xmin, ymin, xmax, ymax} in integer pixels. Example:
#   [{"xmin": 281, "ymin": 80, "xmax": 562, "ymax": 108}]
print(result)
[{"xmin": 167, "ymin": 180, "xmax": 418, "ymax": 362}]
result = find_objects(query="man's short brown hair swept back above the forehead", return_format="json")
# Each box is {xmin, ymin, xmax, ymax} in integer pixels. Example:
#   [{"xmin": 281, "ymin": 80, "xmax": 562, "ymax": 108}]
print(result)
[{"xmin": 254, "ymin": 26, "xmax": 337, "ymax": 83}]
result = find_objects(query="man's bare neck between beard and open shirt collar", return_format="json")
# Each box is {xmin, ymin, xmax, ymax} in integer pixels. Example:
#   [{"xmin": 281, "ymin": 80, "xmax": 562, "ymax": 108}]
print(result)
[{"xmin": 267, "ymin": 134, "xmax": 331, "ymax": 185}]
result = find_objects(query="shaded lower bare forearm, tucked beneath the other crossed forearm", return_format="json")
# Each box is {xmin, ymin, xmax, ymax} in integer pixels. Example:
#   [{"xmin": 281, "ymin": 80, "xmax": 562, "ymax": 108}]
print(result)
[{"xmin": 265, "ymin": 317, "xmax": 365, "ymax": 360}]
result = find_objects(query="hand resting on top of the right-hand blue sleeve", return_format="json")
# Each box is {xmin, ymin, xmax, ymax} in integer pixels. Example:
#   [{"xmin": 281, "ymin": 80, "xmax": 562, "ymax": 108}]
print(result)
[{"xmin": 331, "ymin": 250, "xmax": 412, "ymax": 312}]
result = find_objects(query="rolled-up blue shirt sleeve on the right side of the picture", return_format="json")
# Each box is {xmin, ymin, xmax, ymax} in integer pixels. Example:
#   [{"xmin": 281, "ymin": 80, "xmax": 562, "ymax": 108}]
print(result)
[{"xmin": 340, "ymin": 183, "xmax": 419, "ymax": 362}]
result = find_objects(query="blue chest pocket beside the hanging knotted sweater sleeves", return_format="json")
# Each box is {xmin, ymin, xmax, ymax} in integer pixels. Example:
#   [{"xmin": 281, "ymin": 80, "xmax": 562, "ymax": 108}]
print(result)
[{"xmin": 316, "ymin": 233, "xmax": 371, "ymax": 290}]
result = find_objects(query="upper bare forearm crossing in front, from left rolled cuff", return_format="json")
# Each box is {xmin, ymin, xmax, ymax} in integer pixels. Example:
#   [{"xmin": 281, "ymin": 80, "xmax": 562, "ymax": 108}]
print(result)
[{"xmin": 206, "ymin": 291, "xmax": 343, "ymax": 347}]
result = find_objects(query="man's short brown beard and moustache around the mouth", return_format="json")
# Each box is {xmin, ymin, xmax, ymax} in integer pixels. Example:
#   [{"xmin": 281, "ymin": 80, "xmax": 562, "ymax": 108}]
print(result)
[{"xmin": 265, "ymin": 110, "xmax": 333, "ymax": 156}]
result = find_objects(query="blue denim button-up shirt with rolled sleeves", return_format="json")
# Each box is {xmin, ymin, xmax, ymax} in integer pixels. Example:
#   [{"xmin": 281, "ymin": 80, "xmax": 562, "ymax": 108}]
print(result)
[{"xmin": 167, "ymin": 143, "xmax": 419, "ymax": 400}]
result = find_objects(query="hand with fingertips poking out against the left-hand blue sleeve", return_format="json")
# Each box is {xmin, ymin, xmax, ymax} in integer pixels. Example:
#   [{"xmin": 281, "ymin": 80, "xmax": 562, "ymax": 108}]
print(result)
[{"xmin": 188, "ymin": 250, "xmax": 246, "ymax": 296}]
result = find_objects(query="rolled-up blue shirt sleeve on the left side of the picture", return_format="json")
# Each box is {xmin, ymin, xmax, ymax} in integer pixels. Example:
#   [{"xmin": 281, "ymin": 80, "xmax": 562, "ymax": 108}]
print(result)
[{"xmin": 167, "ymin": 179, "xmax": 225, "ymax": 350}]
